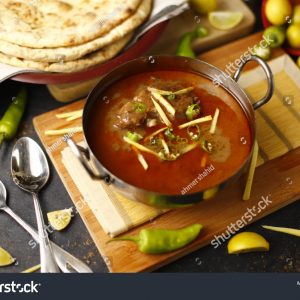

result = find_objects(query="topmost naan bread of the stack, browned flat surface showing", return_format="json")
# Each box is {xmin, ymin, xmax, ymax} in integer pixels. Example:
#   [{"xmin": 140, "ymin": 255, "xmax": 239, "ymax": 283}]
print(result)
[{"xmin": 0, "ymin": 0, "xmax": 142, "ymax": 48}]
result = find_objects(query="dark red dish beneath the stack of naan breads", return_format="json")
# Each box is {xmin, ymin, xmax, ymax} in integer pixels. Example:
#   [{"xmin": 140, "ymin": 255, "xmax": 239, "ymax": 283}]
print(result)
[{"xmin": 12, "ymin": 21, "xmax": 167, "ymax": 84}]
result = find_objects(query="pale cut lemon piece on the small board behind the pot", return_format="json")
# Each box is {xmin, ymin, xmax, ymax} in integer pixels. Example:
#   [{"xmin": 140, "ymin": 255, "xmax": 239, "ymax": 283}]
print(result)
[{"xmin": 208, "ymin": 11, "xmax": 244, "ymax": 30}]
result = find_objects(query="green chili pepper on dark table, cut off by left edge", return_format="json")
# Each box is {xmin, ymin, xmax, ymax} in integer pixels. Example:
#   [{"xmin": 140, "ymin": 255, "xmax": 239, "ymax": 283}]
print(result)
[{"xmin": 0, "ymin": 88, "xmax": 27, "ymax": 145}]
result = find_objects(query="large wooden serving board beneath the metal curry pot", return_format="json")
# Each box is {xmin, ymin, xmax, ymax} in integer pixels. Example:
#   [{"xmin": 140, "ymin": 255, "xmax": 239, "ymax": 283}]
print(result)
[{"xmin": 34, "ymin": 34, "xmax": 300, "ymax": 272}]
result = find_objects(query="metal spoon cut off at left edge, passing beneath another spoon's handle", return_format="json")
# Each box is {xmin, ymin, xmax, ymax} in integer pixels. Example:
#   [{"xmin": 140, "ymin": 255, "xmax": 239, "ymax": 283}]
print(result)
[{"xmin": 0, "ymin": 180, "xmax": 93, "ymax": 273}]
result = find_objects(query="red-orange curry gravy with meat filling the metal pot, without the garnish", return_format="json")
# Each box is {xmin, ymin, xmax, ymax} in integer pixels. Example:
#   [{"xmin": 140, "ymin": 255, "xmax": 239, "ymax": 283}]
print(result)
[{"xmin": 88, "ymin": 71, "xmax": 252, "ymax": 195}]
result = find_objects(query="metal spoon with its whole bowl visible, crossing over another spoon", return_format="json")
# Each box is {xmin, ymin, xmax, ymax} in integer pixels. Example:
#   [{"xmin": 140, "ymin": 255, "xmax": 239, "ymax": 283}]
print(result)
[{"xmin": 11, "ymin": 137, "xmax": 59, "ymax": 273}]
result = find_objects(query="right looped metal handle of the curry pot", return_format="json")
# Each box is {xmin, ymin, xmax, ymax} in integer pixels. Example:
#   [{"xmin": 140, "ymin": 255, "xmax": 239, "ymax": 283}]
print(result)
[{"xmin": 232, "ymin": 55, "xmax": 274, "ymax": 109}]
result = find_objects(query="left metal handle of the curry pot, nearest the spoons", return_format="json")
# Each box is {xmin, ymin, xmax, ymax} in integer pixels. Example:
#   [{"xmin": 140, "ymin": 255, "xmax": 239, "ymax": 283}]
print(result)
[{"xmin": 66, "ymin": 138, "xmax": 111, "ymax": 184}]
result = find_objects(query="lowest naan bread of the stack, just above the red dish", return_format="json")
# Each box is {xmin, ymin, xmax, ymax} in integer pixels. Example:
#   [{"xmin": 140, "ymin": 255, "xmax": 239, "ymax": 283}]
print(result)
[{"xmin": 0, "ymin": 34, "xmax": 132, "ymax": 73}]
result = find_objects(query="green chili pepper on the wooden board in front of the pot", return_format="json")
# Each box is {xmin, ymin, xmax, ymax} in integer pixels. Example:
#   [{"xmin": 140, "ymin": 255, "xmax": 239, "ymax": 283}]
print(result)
[{"xmin": 110, "ymin": 224, "xmax": 203, "ymax": 254}]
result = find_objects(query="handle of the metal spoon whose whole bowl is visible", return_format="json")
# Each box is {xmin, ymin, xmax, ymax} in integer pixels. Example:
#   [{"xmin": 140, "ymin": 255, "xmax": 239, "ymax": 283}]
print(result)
[{"xmin": 32, "ymin": 194, "xmax": 60, "ymax": 273}]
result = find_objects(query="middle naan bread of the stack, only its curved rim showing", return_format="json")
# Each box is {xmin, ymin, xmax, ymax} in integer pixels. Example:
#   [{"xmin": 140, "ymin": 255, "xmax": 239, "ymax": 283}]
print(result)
[{"xmin": 0, "ymin": 0, "xmax": 152, "ymax": 62}]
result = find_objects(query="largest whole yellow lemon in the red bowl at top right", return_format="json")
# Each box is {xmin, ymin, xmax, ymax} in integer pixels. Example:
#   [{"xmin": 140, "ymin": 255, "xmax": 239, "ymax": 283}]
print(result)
[{"xmin": 266, "ymin": 0, "xmax": 292, "ymax": 25}]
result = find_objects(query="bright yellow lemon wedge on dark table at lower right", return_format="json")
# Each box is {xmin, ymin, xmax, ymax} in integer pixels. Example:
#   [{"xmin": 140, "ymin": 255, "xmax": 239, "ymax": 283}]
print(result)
[{"xmin": 227, "ymin": 232, "xmax": 270, "ymax": 254}]
